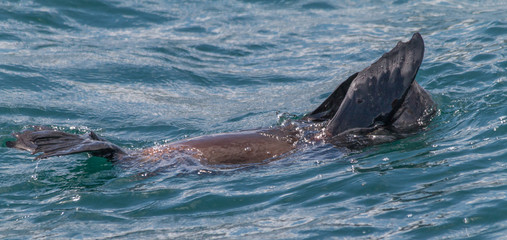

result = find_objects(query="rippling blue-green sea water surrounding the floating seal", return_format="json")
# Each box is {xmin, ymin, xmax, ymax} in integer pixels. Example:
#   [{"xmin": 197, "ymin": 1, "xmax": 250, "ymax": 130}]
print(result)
[{"xmin": 0, "ymin": 0, "xmax": 507, "ymax": 239}]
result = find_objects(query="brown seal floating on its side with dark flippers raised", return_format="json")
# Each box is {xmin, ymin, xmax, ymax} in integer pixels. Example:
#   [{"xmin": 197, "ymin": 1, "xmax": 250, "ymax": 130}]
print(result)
[{"xmin": 6, "ymin": 33, "xmax": 436, "ymax": 165}]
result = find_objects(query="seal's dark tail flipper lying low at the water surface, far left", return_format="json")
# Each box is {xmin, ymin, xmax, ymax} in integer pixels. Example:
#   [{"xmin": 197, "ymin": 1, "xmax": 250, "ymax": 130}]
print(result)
[{"xmin": 6, "ymin": 128, "xmax": 125, "ymax": 159}]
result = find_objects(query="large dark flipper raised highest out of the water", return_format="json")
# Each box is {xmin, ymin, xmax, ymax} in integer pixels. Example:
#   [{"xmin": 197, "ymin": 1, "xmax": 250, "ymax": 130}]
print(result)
[{"xmin": 326, "ymin": 33, "xmax": 424, "ymax": 137}]
